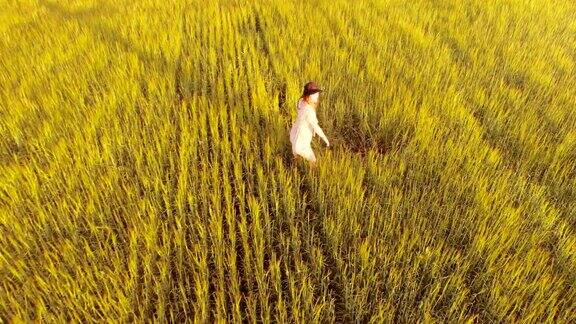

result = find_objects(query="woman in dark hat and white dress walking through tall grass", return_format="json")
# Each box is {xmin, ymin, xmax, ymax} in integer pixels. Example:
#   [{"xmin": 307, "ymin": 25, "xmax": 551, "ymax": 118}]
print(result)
[{"xmin": 290, "ymin": 82, "xmax": 330, "ymax": 166}]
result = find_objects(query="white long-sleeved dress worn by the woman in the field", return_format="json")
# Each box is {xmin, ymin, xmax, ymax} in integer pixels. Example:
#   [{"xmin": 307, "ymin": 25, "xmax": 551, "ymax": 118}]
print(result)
[{"xmin": 290, "ymin": 99, "xmax": 330, "ymax": 162}]
